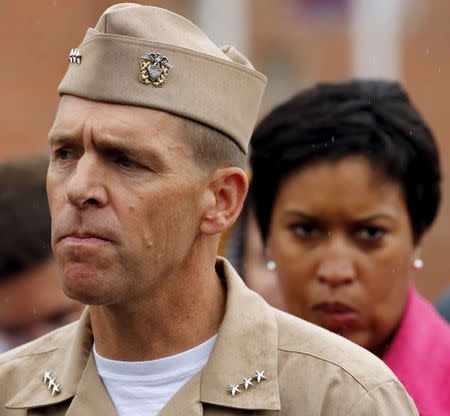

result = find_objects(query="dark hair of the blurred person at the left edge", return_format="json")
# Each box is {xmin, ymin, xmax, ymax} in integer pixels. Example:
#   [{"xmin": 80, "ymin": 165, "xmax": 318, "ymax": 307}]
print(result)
[{"xmin": 0, "ymin": 155, "xmax": 52, "ymax": 281}]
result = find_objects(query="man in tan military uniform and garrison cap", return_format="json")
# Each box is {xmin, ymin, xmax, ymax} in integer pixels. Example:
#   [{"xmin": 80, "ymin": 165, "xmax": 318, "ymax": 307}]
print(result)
[{"xmin": 0, "ymin": 4, "xmax": 417, "ymax": 416}]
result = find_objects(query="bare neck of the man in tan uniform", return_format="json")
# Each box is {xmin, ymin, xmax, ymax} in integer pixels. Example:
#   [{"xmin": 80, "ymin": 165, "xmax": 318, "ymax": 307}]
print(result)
[{"xmin": 91, "ymin": 256, "xmax": 226, "ymax": 361}]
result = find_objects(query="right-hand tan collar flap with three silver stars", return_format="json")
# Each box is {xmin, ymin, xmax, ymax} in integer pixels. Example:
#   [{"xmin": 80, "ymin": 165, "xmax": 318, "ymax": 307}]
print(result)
[{"xmin": 200, "ymin": 258, "xmax": 280, "ymax": 410}]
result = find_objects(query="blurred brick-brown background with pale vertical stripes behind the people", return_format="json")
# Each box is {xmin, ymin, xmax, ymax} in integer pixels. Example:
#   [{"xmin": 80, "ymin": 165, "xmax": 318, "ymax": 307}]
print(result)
[{"xmin": 0, "ymin": 0, "xmax": 450, "ymax": 300}]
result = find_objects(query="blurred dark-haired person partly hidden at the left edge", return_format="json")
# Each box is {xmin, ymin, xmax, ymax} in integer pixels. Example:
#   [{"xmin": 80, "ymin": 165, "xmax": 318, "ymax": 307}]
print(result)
[{"xmin": 0, "ymin": 156, "xmax": 82, "ymax": 351}]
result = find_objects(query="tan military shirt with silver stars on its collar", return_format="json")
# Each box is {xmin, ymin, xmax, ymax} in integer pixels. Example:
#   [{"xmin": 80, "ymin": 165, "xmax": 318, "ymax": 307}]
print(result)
[{"xmin": 0, "ymin": 259, "xmax": 417, "ymax": 416}]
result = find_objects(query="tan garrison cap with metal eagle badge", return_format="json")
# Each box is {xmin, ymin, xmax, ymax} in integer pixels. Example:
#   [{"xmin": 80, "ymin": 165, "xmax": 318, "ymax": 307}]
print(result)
[{"xmin": 58, "ymin": 3, "xmax": 266, "ymax": 151}]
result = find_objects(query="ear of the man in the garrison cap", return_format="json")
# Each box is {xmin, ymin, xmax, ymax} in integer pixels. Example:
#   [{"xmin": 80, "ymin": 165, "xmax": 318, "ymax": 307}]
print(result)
[{"xmin": 200, "ymin": 167, "xmax": 248, "ymax": 235}]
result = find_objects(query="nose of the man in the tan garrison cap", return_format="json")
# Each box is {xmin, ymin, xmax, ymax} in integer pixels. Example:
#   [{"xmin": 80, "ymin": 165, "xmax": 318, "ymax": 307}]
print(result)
[{"xmin": 66, "ymin": 154, "xmax": 108, "ymax": 209}]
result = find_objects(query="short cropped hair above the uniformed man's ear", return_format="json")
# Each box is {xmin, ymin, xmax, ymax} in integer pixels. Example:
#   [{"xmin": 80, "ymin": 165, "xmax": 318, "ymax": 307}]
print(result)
[{"xmin": 182, "ymin": 119, "xmax": 247, "ymax": 170}]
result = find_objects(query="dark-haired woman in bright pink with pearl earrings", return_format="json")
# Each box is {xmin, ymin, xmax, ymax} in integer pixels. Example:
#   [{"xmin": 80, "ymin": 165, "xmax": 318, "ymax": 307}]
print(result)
[{"xmin": 251, "ymin": 80, "xmax": 450, "ymax": 416}]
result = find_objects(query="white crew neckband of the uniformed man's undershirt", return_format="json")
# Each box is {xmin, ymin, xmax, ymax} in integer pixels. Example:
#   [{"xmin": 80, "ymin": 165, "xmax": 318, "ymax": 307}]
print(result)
[{"xmin": 93, "ymin": 335, "xmax": 217, "ymax": 384}]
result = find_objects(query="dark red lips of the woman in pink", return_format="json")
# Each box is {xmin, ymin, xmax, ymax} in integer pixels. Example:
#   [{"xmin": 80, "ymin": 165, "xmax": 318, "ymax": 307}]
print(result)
[{"xmin": 312, "ymin": 302, "xmax": 359, "ymax": 332}]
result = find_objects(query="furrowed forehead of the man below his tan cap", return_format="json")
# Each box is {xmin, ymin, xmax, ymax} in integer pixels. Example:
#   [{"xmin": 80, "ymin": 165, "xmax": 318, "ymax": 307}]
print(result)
[{"xmin": 49, "ymin": 97, "xmax": 193, "ymax": 173}]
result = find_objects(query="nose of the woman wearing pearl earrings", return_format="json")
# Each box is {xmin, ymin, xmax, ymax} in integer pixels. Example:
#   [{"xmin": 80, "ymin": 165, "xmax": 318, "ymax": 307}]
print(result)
[{"xmin": 317, "ymin": 252, "xmax": 356, "ymax": 288}]
